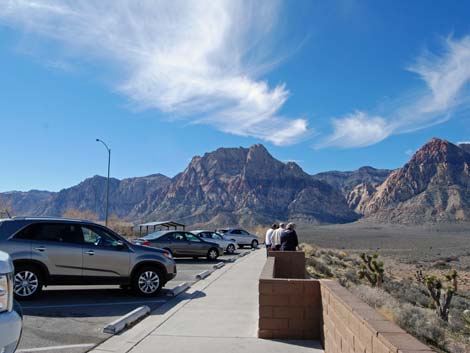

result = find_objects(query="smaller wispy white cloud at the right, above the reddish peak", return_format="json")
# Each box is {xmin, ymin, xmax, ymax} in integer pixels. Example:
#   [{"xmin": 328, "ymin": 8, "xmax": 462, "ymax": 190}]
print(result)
[{"xmin": 322, "ymin": 36, "xmax": 470, "ymax": 148}]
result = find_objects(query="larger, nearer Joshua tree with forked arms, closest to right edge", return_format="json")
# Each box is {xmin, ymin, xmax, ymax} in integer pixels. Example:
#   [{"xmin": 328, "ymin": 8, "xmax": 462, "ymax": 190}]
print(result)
[{"xmin": 416, "ymin": 270, "xmax": 458, "ymax": 322}]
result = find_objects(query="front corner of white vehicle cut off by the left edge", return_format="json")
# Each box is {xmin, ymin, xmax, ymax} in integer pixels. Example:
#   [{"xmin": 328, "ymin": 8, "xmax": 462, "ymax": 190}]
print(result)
[{"xmin": 0, "ymin": 251, "xmax": 23, "ymax": 353}]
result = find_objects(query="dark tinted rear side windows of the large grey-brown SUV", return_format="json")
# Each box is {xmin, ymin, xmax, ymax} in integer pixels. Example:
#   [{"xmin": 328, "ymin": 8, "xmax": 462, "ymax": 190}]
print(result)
[{"xmin": 15, "ymin": 223, "xmax": 83, "ymax": 244}]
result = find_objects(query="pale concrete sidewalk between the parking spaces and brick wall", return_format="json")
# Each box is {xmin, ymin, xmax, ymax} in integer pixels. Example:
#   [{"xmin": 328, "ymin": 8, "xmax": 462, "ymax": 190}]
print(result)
[{"xmin": 92, "ymin": 250, "xmax": 323, "ymax": 353}]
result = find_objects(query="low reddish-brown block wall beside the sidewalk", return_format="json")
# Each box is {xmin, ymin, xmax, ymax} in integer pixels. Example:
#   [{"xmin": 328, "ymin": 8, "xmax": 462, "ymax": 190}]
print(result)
[{"xmin": 258, "ymin": 252, "xmax": 433, "ymax": 353}]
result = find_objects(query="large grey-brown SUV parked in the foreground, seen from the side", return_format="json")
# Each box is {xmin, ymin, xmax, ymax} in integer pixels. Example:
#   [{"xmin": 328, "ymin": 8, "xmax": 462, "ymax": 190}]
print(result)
[{"xmin": 0, "ymin": 217, "xmax": 176, "ymax": 299}]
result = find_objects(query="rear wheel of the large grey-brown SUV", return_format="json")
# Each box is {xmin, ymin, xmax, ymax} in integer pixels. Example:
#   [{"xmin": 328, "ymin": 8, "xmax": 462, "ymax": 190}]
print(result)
[{"xmin": 13, "ymin": 266, "xmax": 43, "ymax": 300}]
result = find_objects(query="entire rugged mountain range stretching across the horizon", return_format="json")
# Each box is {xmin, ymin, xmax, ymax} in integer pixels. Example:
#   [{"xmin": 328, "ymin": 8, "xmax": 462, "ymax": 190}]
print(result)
[{"xmin": 0, "ymin": 138, "xmax": 470, "ymax": 227}]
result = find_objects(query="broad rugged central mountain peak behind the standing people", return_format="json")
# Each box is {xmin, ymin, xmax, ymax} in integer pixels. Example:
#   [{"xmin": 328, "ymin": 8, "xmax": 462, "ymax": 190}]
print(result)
[{"xmin": 148, "ymin": 145, "xmax": 357, "ymax": 225}]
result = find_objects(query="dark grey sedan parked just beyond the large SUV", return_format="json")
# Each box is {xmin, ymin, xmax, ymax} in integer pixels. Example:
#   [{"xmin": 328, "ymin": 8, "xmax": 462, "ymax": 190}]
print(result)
[{"xmin": 134, "ymin": 230, "xmax": 224, "ymax": 260}]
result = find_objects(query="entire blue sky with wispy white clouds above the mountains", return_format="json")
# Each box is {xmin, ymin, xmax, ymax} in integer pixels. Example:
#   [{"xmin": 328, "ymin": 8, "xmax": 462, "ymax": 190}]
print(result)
[{"xmin": 0, "ymin": 0, "xmax": 470, "ymax": 191}]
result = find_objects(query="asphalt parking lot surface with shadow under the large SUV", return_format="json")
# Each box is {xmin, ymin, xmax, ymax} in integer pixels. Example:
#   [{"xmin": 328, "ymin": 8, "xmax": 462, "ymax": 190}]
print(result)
[{"xmin": 14, "ymin": 253, "xmax": 242, "ymax": 353}]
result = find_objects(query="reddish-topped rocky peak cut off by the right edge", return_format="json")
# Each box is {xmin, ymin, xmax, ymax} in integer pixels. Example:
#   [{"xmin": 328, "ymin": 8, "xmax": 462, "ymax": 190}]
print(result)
[{"xmin": 363, "ymin": 138, "xmax": 470, "ymax": 224}]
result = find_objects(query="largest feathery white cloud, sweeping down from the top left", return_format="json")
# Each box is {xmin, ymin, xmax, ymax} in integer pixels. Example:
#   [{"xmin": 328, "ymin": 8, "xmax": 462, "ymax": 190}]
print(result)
[{"xmin": 0, "ymin": 0, "xmax": 308, "ymax": 145}]
